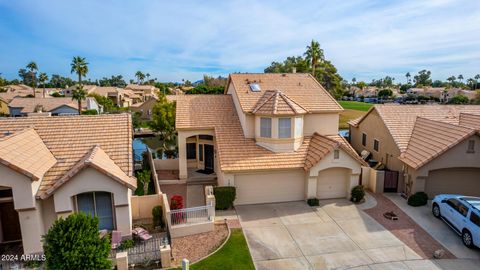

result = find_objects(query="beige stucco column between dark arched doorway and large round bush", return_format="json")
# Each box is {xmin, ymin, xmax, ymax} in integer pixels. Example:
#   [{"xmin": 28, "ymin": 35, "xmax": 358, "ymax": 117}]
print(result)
[{"xmin": 18, "ymin": 208, "xmax": 44, "ymax": 254}]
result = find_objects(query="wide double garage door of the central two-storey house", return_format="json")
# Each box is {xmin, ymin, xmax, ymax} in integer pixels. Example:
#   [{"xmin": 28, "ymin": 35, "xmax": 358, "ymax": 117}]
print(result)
[{"xmin": 235, "ymin": 171, "xmax": 305, "ymax": 205}]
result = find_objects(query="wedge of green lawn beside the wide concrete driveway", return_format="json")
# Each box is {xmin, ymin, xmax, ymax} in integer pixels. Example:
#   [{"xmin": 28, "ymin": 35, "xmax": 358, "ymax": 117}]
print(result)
[{"xmin": 172, "ymin": 229, "xmax": 255, "ymax": 270}]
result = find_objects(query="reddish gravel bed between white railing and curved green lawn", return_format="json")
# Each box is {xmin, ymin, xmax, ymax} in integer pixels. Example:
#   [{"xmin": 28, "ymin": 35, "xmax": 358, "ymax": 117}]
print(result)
[{"xmin": 172, "ymin": 224, "xmax": 228, "ymax": 265}]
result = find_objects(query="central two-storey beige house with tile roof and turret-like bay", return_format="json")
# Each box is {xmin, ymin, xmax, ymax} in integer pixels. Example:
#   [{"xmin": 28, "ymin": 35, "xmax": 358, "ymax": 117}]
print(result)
[{"xmin": 175, "ymin": 73, "xmax": 367, "ymax": 205}]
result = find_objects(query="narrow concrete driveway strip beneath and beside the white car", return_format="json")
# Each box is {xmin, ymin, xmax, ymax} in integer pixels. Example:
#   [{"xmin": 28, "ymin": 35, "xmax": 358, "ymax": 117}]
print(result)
[{"xmin": 383, "ymin": 193, "xmax": 480, "ymax": 260}]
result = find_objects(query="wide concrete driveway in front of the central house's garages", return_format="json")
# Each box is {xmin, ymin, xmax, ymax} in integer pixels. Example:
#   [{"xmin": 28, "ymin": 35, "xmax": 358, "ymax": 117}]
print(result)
[{"xmin": 236, "ymin": 200, "xmax": 432, "ymax": 270}]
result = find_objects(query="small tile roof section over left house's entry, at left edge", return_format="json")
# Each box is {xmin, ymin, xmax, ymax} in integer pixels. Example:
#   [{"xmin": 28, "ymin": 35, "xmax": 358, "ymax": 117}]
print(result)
[{"xmin": 0, "ymin": 128, "xmax": 57, "ymax": 181}]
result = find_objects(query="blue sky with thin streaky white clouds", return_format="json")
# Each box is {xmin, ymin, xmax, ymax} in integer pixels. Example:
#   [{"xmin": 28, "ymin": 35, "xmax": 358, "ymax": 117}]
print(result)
[{"xmin": 0, "ymin": 0, "xmax": 480, "ymax": 81}]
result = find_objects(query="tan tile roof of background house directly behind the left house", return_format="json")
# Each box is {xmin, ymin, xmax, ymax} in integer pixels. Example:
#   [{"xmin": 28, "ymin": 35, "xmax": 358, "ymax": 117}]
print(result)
[{"xmin": 8, "ymin": 97, "xmax": 87, "ymax": 113}]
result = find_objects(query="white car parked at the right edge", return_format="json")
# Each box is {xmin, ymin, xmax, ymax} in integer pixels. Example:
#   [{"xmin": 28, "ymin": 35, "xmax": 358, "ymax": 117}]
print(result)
[{"xmin": 432, "ymin": 194, "xmax": 480, "ymax": 247}]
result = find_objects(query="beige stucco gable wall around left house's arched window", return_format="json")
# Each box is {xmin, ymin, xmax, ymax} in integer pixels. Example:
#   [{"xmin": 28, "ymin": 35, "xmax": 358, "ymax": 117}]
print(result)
[{"xmin": 53, "ymin": 168, "xmax": 132, "ymax": 236}]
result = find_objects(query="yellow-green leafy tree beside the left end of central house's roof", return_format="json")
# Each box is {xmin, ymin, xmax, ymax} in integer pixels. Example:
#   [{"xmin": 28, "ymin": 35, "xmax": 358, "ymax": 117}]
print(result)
[{"xmin": 150, "ymin": 92, "xmax": 176, "ymax": 139}]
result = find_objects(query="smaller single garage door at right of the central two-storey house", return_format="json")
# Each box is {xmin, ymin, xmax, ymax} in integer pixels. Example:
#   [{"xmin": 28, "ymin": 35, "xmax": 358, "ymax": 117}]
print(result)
[{"xmin": 317, "ymin": 168, "xmax": 350, "ymax": 199}]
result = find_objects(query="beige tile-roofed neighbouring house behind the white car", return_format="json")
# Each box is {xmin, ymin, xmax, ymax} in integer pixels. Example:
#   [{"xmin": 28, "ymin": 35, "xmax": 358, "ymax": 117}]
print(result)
[{"xmin": 349, "ymin": 104, "xmax": 480, "ymax": 197}]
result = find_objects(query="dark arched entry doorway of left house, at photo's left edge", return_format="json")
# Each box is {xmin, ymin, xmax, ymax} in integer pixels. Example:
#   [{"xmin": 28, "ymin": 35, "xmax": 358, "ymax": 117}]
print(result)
[{"xmin": 0, "ymin": 202, "xmax": 22, "ymax": 242}]
